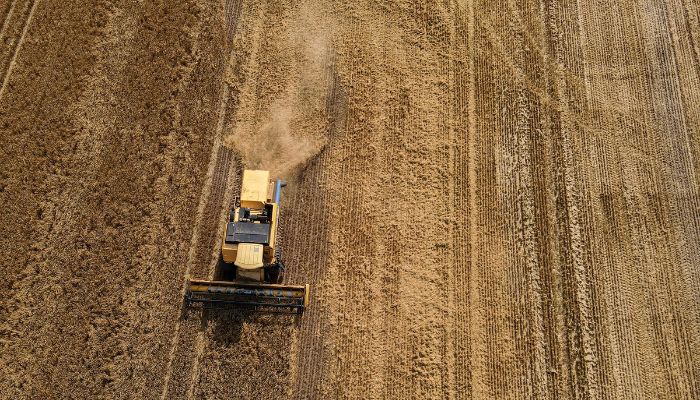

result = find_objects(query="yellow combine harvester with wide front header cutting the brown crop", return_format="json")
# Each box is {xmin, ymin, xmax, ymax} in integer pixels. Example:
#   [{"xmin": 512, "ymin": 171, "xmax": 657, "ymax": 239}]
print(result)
[{"xmin": 185, "ymin": 170, "xmax": 309, "ymax": 312}]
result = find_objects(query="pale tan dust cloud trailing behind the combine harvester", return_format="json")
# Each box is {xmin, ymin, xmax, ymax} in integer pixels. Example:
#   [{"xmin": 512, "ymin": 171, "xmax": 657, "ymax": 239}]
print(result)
[{"xmin": 225, "ymin": 4, "xmax": 332, "ymax": 180}]
